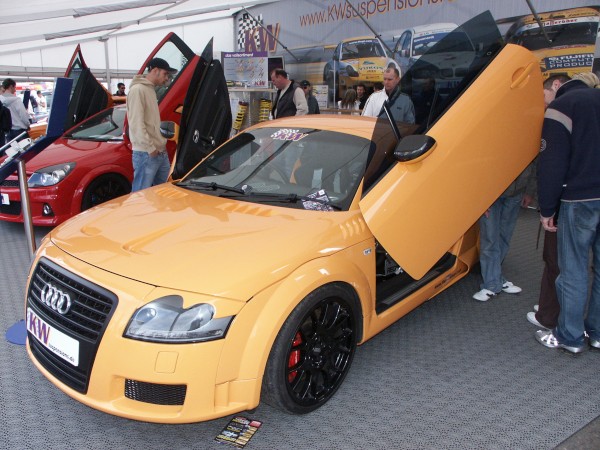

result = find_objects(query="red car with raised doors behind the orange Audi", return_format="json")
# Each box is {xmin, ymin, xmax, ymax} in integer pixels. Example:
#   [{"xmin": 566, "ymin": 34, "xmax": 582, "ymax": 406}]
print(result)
[{"xmin": 0, "ymin": 33, "xmax": 204, "ymax": 226}]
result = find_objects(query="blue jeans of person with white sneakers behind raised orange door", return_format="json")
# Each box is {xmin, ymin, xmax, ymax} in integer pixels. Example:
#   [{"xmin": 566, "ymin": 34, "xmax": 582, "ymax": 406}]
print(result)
[{"xmin": 479, "ymin": 194, "xmax": 523, "ymax": 294}]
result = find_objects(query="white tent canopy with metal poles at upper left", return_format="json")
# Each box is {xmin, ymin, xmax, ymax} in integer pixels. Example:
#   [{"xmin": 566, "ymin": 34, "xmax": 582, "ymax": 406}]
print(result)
[{"xmin": 0, "ymin": 0, "xmax": 278, "ymax": 88}]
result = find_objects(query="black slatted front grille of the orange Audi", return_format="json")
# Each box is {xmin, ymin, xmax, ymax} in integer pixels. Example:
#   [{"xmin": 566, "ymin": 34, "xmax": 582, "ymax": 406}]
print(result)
[{"xmin": 27, "ymin": 258, "xmax": 117, "ymax": 393}]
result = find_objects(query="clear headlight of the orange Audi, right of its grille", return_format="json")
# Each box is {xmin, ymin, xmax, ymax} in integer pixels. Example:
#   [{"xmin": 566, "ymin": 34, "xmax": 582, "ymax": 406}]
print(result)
[{"xmin": 125, "ymin": 295, "xmax": 233, "ymax": 344}]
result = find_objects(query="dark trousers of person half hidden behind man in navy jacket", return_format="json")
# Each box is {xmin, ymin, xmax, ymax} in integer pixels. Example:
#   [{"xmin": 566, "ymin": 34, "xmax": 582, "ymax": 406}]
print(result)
[{"xmin": 535, "ymin": 231, "xmax": 560, "ymax": 329}]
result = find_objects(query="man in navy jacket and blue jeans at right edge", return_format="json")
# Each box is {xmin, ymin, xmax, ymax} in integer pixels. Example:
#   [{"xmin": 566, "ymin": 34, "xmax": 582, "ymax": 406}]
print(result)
[{"xmin": 536, "ymin": 76, "xmax": 600, "ymax": 353}]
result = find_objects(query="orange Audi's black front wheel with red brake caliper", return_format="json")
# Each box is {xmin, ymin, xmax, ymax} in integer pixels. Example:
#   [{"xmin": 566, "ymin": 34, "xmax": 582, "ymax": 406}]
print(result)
[{"xmin": 262, "ymin": 284, "xmax": 359, "ymax": 414}]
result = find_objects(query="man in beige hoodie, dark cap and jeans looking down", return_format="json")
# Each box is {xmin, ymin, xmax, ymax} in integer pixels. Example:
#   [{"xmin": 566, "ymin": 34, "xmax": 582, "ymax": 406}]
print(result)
[{"xmin": 127, "ymin": 58, "xmax": 177, "ymax": 192}]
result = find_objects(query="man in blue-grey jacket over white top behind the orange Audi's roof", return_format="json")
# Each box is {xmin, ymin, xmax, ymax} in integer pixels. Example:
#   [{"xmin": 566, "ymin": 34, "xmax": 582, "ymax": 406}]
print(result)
[{"xmin": 362, "ymin": 67, "xmax": 415, "ymax": 124}]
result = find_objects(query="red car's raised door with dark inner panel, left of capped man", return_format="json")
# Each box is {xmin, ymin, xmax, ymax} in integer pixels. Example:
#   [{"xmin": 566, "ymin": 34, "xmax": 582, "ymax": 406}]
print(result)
[{"xmin": 64, "ymin": 45, "xmax": 112, "ymax": 130}]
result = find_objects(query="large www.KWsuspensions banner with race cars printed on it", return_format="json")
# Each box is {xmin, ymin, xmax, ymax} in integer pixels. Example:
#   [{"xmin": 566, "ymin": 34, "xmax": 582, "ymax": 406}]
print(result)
[{"xmin": 236, "ymin": 0, "xmax": 600, "ymax": 105}]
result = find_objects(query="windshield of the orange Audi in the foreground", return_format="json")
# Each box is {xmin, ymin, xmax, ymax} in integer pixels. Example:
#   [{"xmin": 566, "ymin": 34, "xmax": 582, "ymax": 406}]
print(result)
[{"xmin": 178, "ymin": 127, "xmax": 371, "ymax": 211}]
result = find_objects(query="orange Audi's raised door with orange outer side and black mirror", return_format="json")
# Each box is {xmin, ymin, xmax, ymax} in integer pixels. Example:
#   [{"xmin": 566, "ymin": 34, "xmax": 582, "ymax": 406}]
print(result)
[{"xmin": 360, "ymin": 12, "xmax": 544, "ymax": 279}]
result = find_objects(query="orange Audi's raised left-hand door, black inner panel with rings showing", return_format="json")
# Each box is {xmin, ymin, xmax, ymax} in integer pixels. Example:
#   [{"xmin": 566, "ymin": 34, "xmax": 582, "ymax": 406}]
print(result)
[{"xmin": 171, "ymin": 39, "xmax": 233, "ymax": 180}]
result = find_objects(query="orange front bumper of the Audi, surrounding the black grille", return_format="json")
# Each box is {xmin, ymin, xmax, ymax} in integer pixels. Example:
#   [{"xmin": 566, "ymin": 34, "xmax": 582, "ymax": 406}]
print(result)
[{"xmin": 27, "ymin": 244, "xmax": 261, "ymax": 423}]
